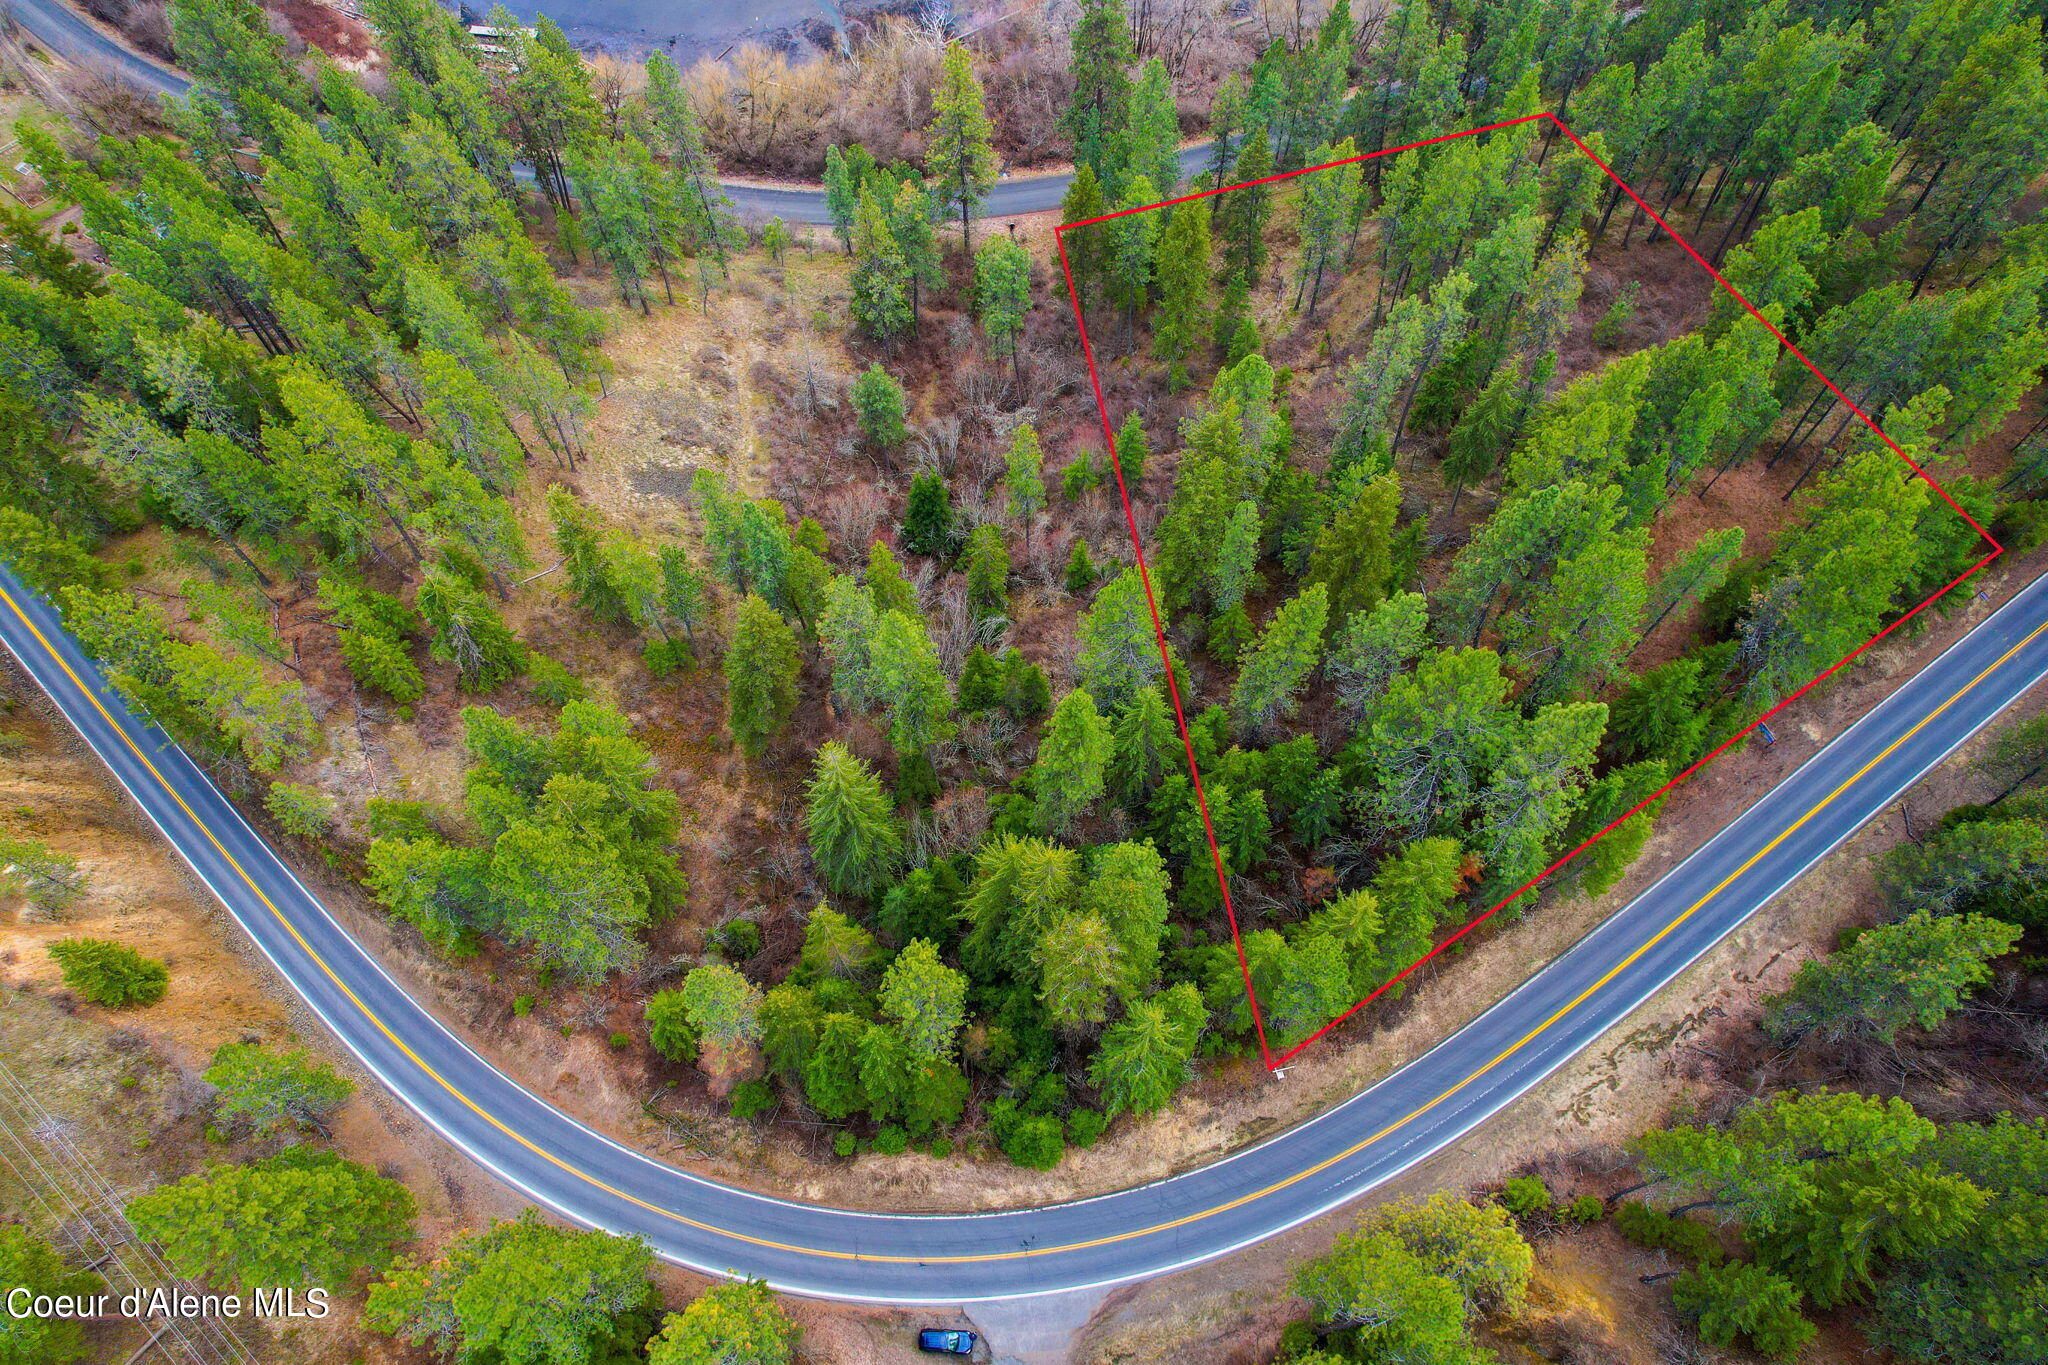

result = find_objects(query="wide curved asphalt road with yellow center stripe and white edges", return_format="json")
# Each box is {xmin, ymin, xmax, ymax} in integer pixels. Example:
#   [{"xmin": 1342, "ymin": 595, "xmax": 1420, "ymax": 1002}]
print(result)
[{"xmin": 0, "ymin": 556, "xmax": 2048, "ymax": 1304}]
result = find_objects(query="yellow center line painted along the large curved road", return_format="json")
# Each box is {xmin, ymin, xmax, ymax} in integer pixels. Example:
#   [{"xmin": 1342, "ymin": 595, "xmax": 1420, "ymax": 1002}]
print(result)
[{"xmin": 0, "ymin": 587, "xmax": 2048, "ymax": 1265}]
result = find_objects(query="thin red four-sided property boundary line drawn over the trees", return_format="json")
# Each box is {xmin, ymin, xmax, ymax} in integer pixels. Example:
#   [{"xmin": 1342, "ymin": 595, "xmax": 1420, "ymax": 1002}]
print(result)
[{"xmin": 1053, "ymin": 111, "xmax": 2005, "ymax": 1070}]
